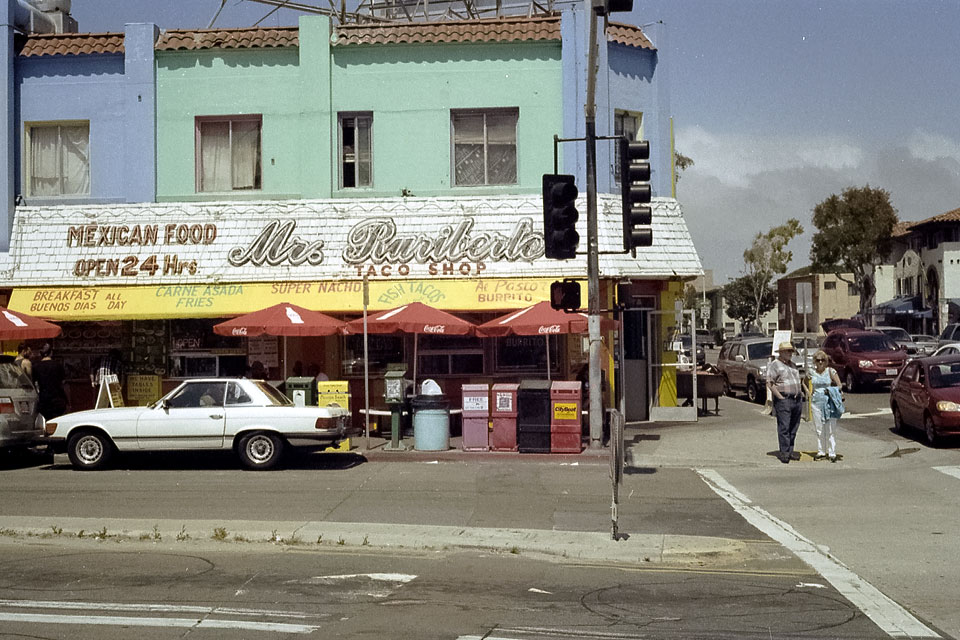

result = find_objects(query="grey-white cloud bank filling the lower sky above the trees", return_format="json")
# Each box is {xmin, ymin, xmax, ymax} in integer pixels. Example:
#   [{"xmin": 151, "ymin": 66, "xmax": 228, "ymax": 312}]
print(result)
[{"xmin": 677, "ymin": 127, "xmax": 960, "ymax": 283}]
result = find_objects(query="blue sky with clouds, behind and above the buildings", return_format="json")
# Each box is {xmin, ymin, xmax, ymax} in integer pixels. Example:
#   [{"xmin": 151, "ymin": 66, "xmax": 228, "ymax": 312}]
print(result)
[{"xmin": 72, "ymin": 0, "xmax": 960, "ymax": 284}]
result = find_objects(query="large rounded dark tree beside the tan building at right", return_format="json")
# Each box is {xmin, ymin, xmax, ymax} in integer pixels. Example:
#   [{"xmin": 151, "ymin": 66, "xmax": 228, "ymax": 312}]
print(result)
[{"xmin": 810, "ymin": 185, "xmax": 898, "ymax": 314}]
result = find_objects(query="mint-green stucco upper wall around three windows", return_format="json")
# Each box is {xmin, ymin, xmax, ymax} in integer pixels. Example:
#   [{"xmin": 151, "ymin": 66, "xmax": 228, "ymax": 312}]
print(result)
[{"xmin": 157, "ymin": 16, "xmax": 563, "ymax": 201}]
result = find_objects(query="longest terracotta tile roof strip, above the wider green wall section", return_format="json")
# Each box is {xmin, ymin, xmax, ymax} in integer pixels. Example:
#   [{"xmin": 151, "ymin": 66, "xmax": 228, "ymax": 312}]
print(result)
[{"xmin": 333, "ymin": 15, "xmax": 560, "ymax": 46}]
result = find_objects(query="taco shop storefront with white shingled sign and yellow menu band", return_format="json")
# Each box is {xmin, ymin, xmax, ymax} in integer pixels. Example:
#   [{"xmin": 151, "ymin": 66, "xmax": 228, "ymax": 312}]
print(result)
[{"xmin": 7, "ymin": 196, "xmax": 700, "ymax": 416}]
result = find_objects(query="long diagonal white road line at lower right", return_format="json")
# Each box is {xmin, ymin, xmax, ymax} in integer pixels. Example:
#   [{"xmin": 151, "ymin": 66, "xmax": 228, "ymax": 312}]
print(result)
[{"xmin": 696, "ymin": 469, "xmax": 940, "ymax": 638}]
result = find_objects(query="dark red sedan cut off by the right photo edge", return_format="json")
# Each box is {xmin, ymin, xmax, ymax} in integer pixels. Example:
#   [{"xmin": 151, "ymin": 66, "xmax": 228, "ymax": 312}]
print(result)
[{"xmin": 890, "ymin": 354, "xmax": 960, "ymax": 446}]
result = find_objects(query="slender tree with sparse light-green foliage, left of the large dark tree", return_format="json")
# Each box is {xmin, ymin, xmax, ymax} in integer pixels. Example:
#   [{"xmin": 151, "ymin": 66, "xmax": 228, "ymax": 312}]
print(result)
[{"xmin": 740, "ymin": 218, "xmax": 803, "ymax": 330}]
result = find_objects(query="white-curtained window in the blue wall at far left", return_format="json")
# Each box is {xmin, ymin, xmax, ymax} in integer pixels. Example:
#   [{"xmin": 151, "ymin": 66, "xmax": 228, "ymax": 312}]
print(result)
[{"xmin": 25, "ymin": 122, "xmax": 90, "ymax": 198}]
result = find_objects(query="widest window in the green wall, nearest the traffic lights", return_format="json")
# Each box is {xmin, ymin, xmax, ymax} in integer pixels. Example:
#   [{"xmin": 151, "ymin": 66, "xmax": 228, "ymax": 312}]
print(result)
[{"xmin": 450, "ymin": 109, "xmax": 520, "ymax": 187}]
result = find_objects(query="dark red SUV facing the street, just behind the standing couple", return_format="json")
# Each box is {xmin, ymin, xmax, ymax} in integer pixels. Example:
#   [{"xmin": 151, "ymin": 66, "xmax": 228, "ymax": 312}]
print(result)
[{"xmin": 822, "ymin": 329, "xmax": 907, "ymax": 391}]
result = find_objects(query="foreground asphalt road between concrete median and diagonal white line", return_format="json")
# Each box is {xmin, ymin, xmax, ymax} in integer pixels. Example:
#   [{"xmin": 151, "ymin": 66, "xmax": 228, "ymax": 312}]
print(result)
[{"xmin": 0, "ymin": 540, "xmax": 886, "ymax": 640}]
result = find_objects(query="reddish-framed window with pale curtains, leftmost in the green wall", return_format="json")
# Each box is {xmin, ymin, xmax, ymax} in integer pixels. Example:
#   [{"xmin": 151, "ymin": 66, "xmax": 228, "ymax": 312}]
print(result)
[{"xmin": 196, "ymin": 115, "xmax": 262, "ymax": 191}]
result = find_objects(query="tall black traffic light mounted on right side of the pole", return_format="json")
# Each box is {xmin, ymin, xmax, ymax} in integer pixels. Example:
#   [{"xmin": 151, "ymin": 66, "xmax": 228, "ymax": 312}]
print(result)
[{"xmin": 620, "ymin": 137, "xmax": 653, "ymax": 251}]
